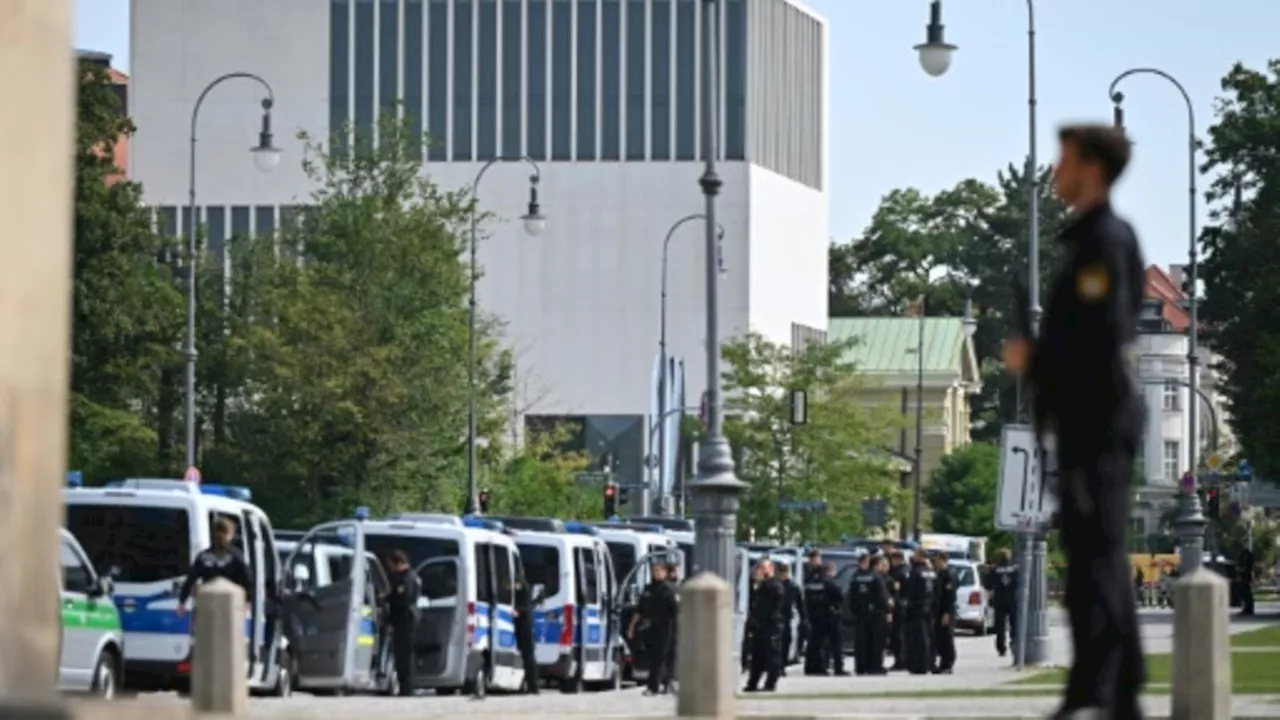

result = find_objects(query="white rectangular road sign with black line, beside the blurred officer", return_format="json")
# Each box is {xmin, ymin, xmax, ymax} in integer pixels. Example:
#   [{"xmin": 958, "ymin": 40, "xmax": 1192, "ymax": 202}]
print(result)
[{"xmin": 996, "ymin": 425, "xmax": 1057, "ymax": 530}]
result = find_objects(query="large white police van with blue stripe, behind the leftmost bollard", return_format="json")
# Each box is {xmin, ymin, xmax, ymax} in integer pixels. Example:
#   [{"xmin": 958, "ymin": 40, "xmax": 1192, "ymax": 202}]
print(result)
[{"xmin": 63, "ymin": 479, "xmax": 280, "ymax": 691}]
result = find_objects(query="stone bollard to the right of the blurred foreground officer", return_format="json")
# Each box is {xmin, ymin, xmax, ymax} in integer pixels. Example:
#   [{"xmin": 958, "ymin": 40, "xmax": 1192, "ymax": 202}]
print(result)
[{"xmin": 1172, "ymin": 568, "xmax": 1231, "ymax": 720}]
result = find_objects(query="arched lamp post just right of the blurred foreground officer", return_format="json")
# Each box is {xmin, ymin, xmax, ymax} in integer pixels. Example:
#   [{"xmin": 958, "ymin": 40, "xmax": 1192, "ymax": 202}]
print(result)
[{"xmin": 1107, "ymin": 68, "xmax": 1206, "ymax": 573}]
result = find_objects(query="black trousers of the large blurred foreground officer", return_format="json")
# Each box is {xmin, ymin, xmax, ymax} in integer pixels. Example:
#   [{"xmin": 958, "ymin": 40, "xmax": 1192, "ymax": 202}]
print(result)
[{"xmin": 1059, "ymin": 418, "xmax": 1146, "ymax": 719}]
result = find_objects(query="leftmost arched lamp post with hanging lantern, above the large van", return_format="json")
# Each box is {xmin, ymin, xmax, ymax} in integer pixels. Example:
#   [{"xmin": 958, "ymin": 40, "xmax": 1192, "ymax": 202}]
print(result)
[{"xmin": 186, "ymin": 73, "xmax": 280, "ymax": 468}]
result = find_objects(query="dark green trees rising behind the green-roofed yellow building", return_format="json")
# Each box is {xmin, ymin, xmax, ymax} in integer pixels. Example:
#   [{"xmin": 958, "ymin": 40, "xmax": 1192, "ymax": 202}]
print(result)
[{"xmin": 828, "ymin": 165, "xmax": 1066, "ymax": 441}]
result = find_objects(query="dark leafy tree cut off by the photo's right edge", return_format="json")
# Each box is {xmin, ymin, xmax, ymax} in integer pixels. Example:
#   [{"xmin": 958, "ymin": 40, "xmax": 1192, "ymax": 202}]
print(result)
[{"xmin": 1199, "ymin": 60, "xmax": 1280, "ymax": 479}]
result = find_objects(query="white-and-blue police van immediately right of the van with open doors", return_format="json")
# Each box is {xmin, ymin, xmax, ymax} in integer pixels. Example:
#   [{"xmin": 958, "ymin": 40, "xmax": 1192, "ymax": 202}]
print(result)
[{"xmin": 504, "ymin": 518, "xmax": 622, "ymax": 693}]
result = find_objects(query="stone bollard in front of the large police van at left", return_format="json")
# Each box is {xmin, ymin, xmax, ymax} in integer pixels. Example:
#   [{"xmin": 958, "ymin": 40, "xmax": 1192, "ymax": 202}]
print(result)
[{"xmin": 191, "ymin": 578, "xmax": 248, "ymax": 716}]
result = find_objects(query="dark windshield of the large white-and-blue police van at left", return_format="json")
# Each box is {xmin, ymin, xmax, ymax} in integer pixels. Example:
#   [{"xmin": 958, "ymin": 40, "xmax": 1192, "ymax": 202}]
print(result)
[{"xmin": 67, "ymin": 503, "xmax": 191, "ymax": 583}]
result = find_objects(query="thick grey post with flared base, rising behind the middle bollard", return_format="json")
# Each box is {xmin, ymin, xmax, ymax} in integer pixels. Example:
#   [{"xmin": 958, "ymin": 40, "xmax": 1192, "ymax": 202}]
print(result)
[{"xmin": 694, "ymin": 0, "xmax": 748, "ymax": 585}]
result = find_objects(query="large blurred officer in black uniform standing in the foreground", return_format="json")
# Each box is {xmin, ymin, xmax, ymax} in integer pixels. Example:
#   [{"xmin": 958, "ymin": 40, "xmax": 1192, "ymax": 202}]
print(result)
[{"xmin": 1005, "ymin": 126, "xmax": 1146, "ymax": 717}]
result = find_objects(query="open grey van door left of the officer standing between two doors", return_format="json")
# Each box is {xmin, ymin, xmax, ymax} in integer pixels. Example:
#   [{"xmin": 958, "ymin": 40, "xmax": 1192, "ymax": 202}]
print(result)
[{"xmin": 283, "ymin": 521, "xmax": 365, "ymax": 688}]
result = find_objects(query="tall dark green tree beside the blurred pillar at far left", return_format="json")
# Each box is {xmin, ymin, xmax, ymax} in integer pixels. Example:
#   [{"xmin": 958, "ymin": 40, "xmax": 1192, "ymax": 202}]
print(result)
[{"xmin": 69, "ymin": 63, "xmax": 183, "ymax": 480}]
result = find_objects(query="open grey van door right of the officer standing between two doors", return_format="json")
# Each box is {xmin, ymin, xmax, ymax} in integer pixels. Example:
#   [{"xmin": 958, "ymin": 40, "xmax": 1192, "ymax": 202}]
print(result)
[{"xmin": 412, "ymin": 557, "xmax": 472, "ymax": 687}]
